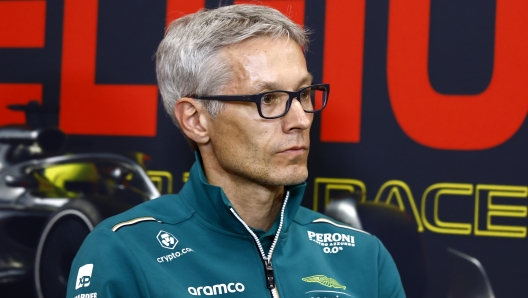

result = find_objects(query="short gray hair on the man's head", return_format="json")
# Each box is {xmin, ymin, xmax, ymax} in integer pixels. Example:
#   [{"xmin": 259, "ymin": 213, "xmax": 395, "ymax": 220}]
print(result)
[{"xmin": 156, "ymin": 5, "xmax": 308, "ymax": 127}]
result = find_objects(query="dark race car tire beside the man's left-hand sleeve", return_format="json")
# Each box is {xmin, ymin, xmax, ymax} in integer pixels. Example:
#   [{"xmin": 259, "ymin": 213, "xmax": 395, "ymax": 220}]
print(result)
[{"xmin": 34, "ymin": 199, "xmax": 103, "ymax": 298}]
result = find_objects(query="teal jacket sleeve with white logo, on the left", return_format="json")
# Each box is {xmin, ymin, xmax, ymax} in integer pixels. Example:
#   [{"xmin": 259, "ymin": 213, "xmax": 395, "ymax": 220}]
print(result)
[{"xmin": 66, "ymin": 228, "xmax": 149, "ymax": 298}]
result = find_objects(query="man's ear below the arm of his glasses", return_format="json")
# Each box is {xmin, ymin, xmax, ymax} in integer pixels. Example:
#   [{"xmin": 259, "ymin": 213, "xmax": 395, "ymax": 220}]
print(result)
[{"xmin": 174, "ymin": 97, "xmax": 209, "ymax": 144}]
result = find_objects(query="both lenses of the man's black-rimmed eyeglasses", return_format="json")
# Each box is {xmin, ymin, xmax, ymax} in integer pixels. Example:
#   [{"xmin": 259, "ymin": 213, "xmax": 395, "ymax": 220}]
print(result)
[{"xmin": 260, "ymin": 87, "xmax": 326, "ymax": 117}]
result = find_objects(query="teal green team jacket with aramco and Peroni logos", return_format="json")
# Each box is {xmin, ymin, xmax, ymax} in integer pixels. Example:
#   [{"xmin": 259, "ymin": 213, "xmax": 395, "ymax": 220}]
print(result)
[{"xmin": 67, "ymin": 158, "xmax": 405, "ymax": 298}]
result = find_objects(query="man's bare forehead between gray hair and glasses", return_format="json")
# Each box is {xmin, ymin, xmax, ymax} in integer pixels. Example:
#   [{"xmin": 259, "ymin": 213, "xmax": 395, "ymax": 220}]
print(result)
[{"xmin": 224, "ymin": 36, "xmax": 312, "ymax": 94}]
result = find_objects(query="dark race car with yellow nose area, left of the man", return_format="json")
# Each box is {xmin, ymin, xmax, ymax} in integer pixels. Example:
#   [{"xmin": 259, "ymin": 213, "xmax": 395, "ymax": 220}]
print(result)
[{"xmin": 0, "ymin": 114, "xmax": 160, "ymax": 298}]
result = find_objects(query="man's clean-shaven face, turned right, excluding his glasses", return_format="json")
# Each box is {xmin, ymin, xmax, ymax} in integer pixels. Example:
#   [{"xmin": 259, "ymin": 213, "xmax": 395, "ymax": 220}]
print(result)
[{"xmin": 209, "ymin": 36, "xmax": 313, "ymax": 186}]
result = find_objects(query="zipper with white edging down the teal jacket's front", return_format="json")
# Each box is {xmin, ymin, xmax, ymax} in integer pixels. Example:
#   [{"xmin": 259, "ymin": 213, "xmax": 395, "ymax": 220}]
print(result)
[{"xmin": 229, "ymin": 191, "xmax": 290, "ymax": 298}]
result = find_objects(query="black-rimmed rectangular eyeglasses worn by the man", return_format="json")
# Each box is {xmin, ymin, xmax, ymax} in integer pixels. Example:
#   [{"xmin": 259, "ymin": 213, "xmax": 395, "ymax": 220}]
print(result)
[{"xmin": 192, "ymin": 84, "xmax": 330, "ymax": 119}]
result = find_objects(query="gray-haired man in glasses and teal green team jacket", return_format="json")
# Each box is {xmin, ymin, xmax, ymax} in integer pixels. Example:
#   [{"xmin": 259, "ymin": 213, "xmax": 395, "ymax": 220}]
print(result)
[{"xmin": 68, "ymin": 5, "xmax": 404, "ymax": 298}]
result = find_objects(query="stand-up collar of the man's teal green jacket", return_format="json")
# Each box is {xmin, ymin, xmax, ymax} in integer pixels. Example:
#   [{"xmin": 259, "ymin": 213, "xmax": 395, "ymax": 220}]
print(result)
[{"xmin": 180, "ymin": 151, "xmax": 306, "ymax": 235}]
